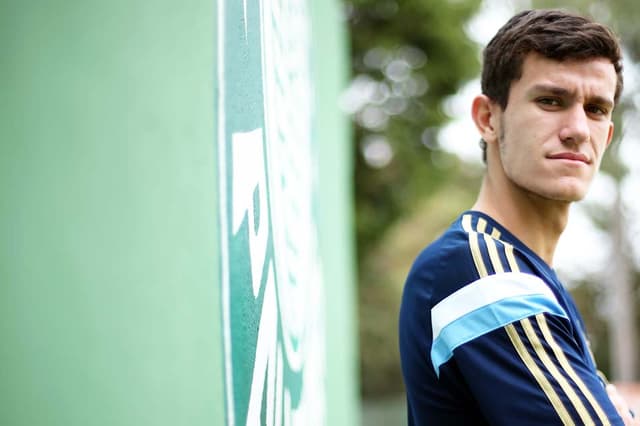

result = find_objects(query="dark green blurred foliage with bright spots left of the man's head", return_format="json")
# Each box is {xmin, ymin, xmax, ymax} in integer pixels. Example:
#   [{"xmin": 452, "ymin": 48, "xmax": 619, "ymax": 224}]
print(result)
[{"xmin": 345, "ymin": 0, "xmax": 480, "ymax": 259}]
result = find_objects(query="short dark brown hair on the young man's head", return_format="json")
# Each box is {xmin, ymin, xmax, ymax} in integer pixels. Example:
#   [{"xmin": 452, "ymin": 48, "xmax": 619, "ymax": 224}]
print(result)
[{"xmin": 480, "ymin": 9, "xmax": 623, "ymax": 161}]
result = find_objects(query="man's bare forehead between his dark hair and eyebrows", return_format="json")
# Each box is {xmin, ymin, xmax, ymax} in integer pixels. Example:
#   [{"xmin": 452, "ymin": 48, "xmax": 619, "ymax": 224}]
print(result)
[{"xmin": 511, "ymin": 53, "xmax": 617, "ymax": 102}]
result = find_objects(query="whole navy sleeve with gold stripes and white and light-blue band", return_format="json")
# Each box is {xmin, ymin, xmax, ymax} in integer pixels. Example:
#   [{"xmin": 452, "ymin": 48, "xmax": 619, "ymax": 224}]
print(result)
[{"xmin": 431, "ymin": 215, "xmax": 623, "ymax": 425}]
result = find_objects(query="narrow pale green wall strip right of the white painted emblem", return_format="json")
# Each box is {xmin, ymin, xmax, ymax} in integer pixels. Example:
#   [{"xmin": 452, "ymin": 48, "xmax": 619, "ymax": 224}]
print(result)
[{"xmin": 310, "ymin": 0, "xmax": 360, "ymax": 425}]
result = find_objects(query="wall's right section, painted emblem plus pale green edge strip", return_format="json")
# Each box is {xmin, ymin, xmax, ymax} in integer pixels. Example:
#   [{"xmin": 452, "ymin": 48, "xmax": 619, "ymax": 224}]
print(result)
[{"xmin": 218, "ymin": 0, "xmax": 358, "ymax": 425}]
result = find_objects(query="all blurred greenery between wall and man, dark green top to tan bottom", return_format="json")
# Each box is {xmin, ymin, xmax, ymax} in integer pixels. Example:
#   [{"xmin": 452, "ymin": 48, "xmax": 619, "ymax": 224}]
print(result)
[{"xmin": 343, "ymin": 0, "xmax": 481, "ymax": 396}]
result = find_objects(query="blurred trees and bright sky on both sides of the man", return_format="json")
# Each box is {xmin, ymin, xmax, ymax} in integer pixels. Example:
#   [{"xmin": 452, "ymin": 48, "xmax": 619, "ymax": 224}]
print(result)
[{"xmin": 350, "ymin": 0, "xmax": 640, "ymax": 425}]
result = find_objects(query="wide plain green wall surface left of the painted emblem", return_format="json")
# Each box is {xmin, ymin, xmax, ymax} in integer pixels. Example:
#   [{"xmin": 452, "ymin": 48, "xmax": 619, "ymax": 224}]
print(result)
[{"xmin": 0, "ymin": 0, "xmax": 223, "ymax": 426}]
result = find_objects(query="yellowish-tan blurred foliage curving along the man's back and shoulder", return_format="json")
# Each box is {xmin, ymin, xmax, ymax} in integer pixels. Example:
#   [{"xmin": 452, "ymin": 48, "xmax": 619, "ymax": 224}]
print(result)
[{"xmin": 360, "ymin": 169, "xmax": 479, "ymax": 396}]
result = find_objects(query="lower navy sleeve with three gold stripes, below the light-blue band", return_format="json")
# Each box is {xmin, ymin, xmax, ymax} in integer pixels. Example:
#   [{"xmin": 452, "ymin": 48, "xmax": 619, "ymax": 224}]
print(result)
[{"xmin": 442, "ymin": 296, "xmax": 623, "ymax": 425}]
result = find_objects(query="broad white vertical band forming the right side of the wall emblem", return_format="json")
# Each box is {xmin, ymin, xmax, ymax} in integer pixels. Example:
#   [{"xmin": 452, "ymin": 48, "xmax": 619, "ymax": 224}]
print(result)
[{"xmin": 261, "ymin": 0, "xmax": 325, "ymax": 425}]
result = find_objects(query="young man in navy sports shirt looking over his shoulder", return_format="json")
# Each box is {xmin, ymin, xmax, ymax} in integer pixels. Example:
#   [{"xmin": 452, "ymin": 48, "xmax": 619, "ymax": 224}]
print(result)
[{"xmin": 399, "ymin": 10, "xmax": 640, "ymax": 426}]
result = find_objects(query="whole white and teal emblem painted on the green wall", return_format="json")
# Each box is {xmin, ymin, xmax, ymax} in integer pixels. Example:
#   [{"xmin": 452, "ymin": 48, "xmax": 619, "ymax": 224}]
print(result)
[{"xmin": 218, "ymin": 0, "xmax": 325, "ymax": 426}]
